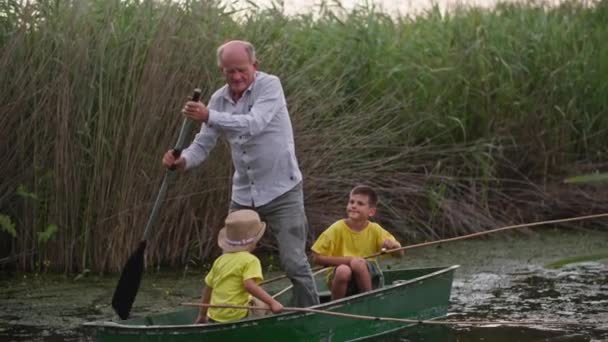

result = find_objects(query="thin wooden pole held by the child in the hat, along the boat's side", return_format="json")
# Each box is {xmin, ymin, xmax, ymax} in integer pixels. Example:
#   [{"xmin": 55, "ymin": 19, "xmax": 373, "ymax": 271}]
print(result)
[{"xmin": 182, "ymin": 303, "xmax": 597, "ymax": 326}]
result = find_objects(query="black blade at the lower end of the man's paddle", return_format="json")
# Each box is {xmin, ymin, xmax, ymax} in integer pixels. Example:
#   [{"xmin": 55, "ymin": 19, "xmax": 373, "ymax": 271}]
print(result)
[{"xmin": 112, "ymin": 240, "xmax": 146, "ymax": 319}]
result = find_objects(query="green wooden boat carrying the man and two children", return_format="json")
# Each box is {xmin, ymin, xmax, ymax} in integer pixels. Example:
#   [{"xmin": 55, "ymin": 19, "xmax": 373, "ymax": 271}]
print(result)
[{"xmin": 84, "ymin": 265, "xmax": 459, "ymax": 342}]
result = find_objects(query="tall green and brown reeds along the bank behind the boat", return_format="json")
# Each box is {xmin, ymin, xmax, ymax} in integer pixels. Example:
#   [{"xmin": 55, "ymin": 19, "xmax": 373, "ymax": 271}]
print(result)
[{"xmin": 0, "ymin": 0, "xmax": 608, "ymax": 273}]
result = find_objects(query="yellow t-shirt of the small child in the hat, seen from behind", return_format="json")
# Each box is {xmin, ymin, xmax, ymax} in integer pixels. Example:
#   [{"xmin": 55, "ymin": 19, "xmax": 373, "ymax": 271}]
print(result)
[{"xmin": 205, "ymin": 252, "xmax": 264, "ymax": 322}]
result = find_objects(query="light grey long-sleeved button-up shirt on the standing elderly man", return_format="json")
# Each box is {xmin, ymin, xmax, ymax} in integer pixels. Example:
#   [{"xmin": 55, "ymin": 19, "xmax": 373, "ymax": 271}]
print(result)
[{"xmin": 182, "ymin": 71, "xmax": 302, "ymax": 206}]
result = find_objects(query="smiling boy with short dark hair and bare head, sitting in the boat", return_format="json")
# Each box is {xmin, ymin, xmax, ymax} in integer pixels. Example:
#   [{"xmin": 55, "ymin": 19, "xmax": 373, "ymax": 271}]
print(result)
[{"xmin": 311, "ymin": 185, "xmax": 403, "ymax": 300}]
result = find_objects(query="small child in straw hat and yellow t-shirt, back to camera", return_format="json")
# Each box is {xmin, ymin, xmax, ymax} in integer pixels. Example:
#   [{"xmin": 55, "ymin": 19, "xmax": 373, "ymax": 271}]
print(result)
[{"xmin": 195, "ymin": 209, "xmax": 283, "ymax": 323}]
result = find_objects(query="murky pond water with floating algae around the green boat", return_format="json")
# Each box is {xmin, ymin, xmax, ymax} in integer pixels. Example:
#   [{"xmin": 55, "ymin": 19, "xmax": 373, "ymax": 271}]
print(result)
[{"xmin": 0, "ymin": 230, "xmax": 608, "ymax": 342}]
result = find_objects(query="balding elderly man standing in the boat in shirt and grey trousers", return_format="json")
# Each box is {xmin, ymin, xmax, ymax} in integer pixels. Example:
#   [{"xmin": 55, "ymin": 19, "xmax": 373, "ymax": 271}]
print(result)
[{"xmin": 163, "ymin": 40, "xmax": 319, "ymax": 307}]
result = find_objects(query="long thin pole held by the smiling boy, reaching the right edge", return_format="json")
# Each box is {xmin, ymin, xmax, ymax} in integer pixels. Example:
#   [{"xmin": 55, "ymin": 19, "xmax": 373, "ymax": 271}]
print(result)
[{"xmin": 260, "ymin": 213, "xmax": 608, "ymax": 288}]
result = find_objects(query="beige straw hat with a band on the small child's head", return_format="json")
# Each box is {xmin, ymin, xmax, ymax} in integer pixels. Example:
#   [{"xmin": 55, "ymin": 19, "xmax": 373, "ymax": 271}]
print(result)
[{"xmin": 217, "ymin": 209, "xmax": 266, "ymax": 252}]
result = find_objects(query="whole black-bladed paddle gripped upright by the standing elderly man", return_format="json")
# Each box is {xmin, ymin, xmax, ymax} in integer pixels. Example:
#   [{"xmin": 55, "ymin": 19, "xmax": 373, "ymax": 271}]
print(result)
[{"xmin": 112, "ymin": 88, "xmax": 201, "ymax": 319}]
